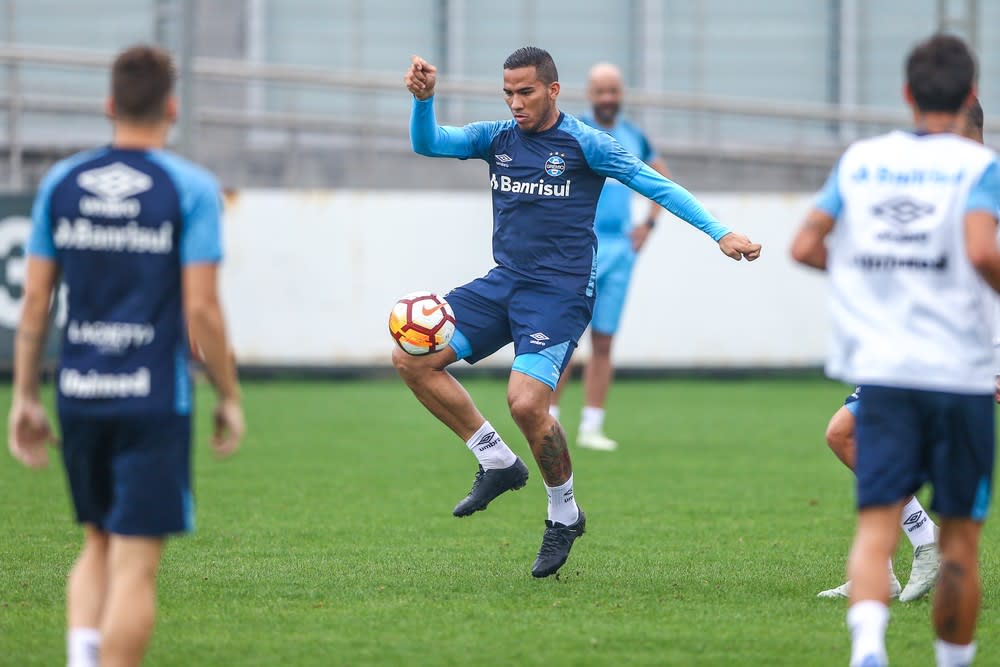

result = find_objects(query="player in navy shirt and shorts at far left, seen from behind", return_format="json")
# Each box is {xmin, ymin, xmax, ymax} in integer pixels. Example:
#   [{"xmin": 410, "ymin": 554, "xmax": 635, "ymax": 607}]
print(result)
[{"xmin": 8, "ymin": 46, "xmax": 244, "ymax": 667}]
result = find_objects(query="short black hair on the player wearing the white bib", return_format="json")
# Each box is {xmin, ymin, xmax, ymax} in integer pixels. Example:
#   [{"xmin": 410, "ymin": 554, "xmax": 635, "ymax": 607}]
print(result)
[{"xmin": 906, "ymin": 33, "xmax": 976, "ymax": 113}]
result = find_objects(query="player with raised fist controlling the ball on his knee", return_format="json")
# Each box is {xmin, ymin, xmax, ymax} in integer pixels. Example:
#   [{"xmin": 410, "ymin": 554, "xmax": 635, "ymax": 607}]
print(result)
[{"xmin": 393, "ymin": 47, "xmax": 760, "ymax": 577}]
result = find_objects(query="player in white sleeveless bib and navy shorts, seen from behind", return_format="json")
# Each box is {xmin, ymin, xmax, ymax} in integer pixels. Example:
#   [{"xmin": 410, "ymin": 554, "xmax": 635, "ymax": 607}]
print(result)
[{"xmin": 792, "ymin": 35, "xmax": 1000, "ymax": 667}]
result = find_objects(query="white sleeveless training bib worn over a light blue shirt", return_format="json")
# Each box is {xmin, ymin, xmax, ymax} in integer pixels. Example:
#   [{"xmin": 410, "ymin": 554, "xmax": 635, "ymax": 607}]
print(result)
[{"xmin": 824, "ymin": 132, "xmax": 997, "ymax": 393}]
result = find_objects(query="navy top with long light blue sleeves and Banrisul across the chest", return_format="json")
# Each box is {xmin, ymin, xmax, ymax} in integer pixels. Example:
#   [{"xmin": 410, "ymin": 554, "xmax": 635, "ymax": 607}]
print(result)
[{"xmin": 410, "ymin": 97, "xmax": 729, "ymax": 296}]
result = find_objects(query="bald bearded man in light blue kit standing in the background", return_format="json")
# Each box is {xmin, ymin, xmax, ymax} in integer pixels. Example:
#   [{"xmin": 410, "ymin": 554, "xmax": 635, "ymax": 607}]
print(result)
[{"xmin": 549, "ymin": 63, "xmax": 670, "ymax": 451}]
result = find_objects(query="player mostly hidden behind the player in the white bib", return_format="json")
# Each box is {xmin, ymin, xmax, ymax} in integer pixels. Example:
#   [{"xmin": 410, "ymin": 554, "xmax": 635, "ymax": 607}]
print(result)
[{"xmin": 819, "ymin": 99, "xmax": 988, "ymax": 602}]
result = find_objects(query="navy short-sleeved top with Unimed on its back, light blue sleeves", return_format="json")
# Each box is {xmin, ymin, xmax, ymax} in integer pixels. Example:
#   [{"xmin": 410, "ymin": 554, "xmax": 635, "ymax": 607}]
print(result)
[{"xmin": 27, "ymin": 147, "xmax": 222, "ymax": 416}]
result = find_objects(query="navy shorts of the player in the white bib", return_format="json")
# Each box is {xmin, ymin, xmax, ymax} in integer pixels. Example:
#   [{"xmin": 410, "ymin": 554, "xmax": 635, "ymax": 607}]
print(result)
[{"xmin": 856, "ymin": 385, "xmax": 994, "ymax": 521}]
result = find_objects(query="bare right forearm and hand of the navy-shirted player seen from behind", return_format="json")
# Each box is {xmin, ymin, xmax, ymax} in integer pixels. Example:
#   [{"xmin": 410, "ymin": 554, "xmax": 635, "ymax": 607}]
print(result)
[{"xmin": 183, "ymin": 263, "xmax": 246, "ymax": 457}]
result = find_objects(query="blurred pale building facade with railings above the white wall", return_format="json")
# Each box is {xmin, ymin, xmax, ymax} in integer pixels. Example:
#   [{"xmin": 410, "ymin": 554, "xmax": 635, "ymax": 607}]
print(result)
[{"xmin": 0, "ymin": 0, "xmax": 1000, "ymax": 191}]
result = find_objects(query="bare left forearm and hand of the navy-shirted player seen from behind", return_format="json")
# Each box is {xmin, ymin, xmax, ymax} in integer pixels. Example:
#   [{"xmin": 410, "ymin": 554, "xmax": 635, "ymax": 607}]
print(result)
[{"xmin": 7, "ymin": 257, "xmax": 59, "ymax": 468}]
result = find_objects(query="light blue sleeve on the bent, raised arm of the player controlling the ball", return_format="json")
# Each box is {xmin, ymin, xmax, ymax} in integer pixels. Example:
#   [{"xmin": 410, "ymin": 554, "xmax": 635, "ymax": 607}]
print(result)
[{"xmin": 410, "ymin": 97, "xmax": 505, "ymax": 160}]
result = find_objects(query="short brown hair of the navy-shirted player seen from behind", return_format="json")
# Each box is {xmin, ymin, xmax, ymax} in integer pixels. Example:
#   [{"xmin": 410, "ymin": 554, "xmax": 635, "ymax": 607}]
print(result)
[{"xmin": 111, "ymin": 45, "xmax": 177, "ymax": 123}]
